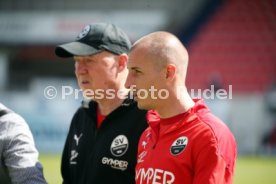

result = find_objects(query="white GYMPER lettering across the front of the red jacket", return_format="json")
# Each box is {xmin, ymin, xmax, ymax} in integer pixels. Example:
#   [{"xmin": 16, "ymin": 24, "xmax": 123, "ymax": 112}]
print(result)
[{"xmin": 135, "ymin": 168, "xmax": 175, "ymax": 184}]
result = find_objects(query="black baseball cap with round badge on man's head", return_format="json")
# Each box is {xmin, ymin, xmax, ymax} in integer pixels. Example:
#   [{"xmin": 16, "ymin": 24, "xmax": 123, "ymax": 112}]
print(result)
[{"xmin": 55, "ymin": 23, "xmax": 131, "ymax": 57}]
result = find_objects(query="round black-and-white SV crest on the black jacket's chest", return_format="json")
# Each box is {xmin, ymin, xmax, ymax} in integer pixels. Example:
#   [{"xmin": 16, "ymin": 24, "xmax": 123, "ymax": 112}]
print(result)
[{"xmin": 110, "ymin": 135, "xmax": 128, "ymax": 157}]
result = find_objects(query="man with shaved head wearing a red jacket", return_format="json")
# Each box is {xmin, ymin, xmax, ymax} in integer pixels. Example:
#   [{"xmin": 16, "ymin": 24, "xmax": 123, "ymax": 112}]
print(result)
[{"xmin": 126, "ymin": 32, "xmax": 237, "ymax": 184}]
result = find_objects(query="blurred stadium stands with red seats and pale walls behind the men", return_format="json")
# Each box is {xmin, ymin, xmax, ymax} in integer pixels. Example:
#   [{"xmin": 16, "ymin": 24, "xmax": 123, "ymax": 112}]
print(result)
[{"xmin": 0, "ymin": 0, "xmax": 276, "ymax": 181}]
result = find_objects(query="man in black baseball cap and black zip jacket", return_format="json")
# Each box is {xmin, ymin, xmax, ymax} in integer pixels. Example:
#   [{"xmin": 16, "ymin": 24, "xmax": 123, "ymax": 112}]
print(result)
[{"xmin": 55, "ymin": 23, "xmax": 147, "ymax": 184}]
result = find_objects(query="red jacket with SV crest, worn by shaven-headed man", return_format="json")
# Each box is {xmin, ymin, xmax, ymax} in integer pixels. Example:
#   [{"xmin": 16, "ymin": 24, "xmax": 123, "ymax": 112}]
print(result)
[{"xmin": 135, "ymin": 100, "xmax": 237, "ymax": 184}]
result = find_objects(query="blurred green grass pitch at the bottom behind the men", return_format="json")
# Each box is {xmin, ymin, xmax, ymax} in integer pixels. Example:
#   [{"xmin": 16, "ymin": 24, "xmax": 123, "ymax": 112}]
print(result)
[{"xmin": 40, "ymin": 154, "xmax": 276, "ymax": 184}]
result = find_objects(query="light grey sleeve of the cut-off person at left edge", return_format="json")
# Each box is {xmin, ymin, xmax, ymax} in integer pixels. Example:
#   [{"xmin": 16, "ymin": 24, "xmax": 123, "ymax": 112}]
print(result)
[{"xmin": 3, "ymin": 113, "xmax": 47, "ymax": 184}]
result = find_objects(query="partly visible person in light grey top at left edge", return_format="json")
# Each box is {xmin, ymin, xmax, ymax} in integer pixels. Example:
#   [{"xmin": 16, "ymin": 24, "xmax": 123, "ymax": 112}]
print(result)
[{"xmin": 0, "ymin": 103, "xmax": 46, "ymax": 184}]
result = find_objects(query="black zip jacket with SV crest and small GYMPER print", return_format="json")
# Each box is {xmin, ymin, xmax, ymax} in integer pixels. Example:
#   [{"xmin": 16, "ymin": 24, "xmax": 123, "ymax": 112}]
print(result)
[{"xmin": 61, "ymin": 100, "xmax": 147, "ymax": 184}]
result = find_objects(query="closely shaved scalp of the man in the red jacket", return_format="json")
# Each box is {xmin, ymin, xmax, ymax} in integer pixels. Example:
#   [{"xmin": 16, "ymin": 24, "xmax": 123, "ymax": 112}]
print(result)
[{"xmin": 131, "ymin": 31, "xmax": 188, "ymax": 80}]
